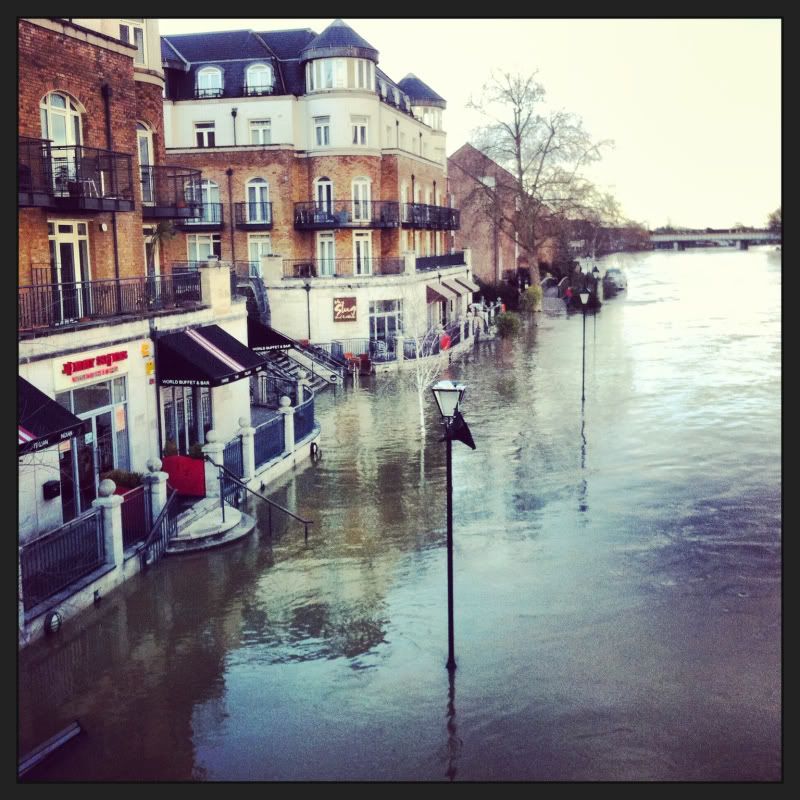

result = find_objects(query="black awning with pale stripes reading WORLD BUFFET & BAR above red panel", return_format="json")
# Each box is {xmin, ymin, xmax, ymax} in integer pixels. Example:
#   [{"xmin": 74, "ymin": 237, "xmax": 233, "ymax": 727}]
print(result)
[{"xmin": 156, "ymin": 325, "xmax": 266, "ymax": 386}]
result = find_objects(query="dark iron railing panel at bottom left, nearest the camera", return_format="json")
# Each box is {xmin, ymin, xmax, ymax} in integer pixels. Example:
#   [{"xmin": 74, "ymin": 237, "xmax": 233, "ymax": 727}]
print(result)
[{"xmin": 20, "ymin": 508, "xmax": 106, "ymax": 610}]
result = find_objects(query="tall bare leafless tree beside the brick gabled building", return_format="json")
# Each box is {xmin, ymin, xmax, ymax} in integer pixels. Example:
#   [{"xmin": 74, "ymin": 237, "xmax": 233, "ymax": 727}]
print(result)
[{"xmin": 468, "ymin": 72, "xmax": 611, "ymax": 283}]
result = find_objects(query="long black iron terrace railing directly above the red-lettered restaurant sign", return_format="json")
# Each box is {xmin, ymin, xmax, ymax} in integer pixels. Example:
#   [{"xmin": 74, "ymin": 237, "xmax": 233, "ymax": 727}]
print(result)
[{"xmin": 18, "ymin": 272, "xmax": 201, "ymax": 330}]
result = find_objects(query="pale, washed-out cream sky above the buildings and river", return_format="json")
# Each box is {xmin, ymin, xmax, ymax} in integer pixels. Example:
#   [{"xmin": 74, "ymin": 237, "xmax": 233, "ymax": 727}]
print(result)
[{"xmin": 159, "ymin": 17, "xmax": 781, "ymax": 228}]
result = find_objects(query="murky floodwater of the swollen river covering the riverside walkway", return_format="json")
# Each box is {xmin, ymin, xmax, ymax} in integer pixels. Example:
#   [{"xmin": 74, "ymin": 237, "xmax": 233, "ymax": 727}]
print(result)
[{"xmin": 19, "ymin": 248, "xmax": 782, "ymax": 781}]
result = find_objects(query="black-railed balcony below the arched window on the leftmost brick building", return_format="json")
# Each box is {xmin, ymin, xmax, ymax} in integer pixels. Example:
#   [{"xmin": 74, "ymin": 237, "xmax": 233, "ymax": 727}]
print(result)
[{"xmin": 18, "ymin": 139, "xmax": 133, "ymax": 211}]
